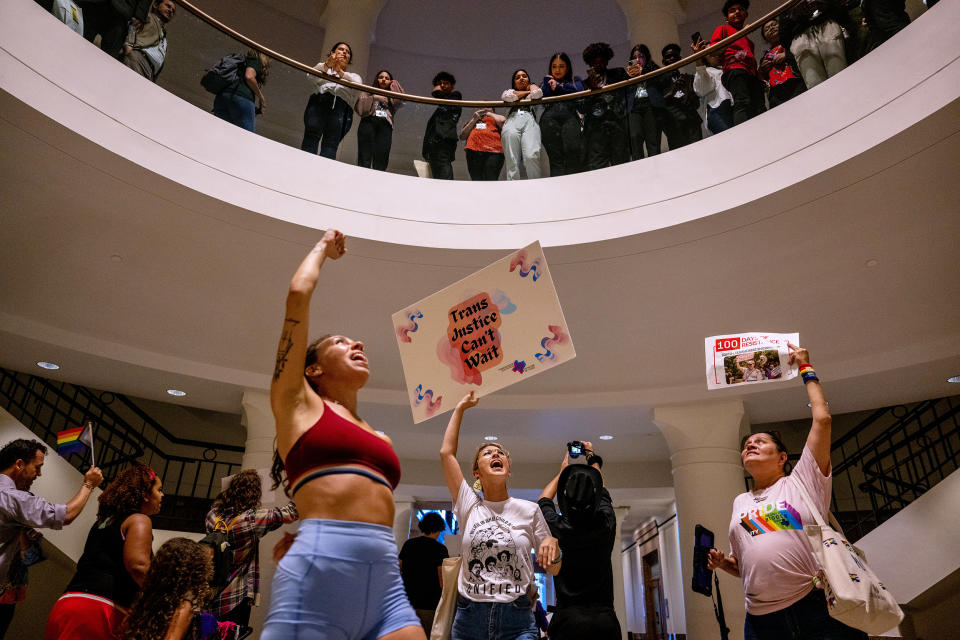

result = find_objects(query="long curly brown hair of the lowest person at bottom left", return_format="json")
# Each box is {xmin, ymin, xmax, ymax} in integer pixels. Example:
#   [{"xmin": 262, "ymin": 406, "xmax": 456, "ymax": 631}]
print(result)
[{"xmin": 122, "ymin": 538, "xmax": 213, "ymax": 640}]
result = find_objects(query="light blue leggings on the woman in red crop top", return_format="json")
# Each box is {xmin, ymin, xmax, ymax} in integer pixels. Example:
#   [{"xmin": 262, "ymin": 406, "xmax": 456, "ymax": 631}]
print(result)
[{"xmin": 260, "ymin": 519, "xmax": 420, "ymax": 640}]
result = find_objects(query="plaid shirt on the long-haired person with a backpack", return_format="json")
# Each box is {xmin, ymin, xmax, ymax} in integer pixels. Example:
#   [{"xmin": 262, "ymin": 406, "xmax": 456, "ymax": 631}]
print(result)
[{"xmin": 206, "ymin": 502, "xmax": 298, "ymax": 618}]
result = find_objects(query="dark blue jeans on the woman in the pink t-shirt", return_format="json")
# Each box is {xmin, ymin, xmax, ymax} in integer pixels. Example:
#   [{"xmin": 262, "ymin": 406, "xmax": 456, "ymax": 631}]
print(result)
[{"xmin": 743, "ymin": 589, "xmax": 867, "ymax": 640}]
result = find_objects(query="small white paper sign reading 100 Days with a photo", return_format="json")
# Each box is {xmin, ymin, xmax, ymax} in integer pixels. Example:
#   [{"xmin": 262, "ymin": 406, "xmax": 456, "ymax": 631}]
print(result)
[{"xmin": 704, "ymin": 333, "xmax": 800, "ymax": 389}]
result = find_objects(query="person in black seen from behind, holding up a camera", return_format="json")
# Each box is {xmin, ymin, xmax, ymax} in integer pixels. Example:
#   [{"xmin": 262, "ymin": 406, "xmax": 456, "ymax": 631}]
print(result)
[{"xmin": 538, "ymin": 442, "xmax": 621, "ymax": 640}]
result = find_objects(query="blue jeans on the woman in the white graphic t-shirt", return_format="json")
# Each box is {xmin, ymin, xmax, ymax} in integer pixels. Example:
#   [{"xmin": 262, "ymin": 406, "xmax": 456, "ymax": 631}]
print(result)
[{"xmin": 450, "ymin": 595, "xmax": 540, "ymax": 640}]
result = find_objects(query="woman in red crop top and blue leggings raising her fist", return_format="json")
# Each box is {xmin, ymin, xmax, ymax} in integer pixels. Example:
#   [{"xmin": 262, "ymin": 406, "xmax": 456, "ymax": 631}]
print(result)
[{"xmin": 260, "ymin": 229, "xmax": 425, "ymax": 640}]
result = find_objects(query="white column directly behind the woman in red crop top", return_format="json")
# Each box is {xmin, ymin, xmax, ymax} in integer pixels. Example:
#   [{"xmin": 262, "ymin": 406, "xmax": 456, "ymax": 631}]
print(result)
[{"xmin": 241, "ymin": 389, "xmax": 297, "ymax": 629}]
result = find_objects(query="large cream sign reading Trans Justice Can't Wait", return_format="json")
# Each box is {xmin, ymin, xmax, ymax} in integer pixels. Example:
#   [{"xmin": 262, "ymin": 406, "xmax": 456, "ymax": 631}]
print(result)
[{"xmin": 393, "ymin": 242, "xmax": 576, "ymax": 422}]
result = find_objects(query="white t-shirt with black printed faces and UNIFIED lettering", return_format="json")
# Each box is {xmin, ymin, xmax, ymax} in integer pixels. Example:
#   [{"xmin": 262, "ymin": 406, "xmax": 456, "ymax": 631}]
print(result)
[{"xmin": 453, "ymin": 480, "xmax": 550, "ymax": 602}]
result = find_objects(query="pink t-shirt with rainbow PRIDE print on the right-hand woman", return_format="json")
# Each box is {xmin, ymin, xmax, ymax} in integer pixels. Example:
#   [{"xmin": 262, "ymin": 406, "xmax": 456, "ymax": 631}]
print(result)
[{"xmin": 730, "ymin": 447, "xmax": 833, "ymax": 615}]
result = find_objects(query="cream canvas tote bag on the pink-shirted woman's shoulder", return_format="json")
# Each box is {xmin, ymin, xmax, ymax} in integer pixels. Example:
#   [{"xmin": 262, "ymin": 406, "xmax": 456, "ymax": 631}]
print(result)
[{"xmin": 794, "ymin": 481, "xmax": 903, "ymax": 635}]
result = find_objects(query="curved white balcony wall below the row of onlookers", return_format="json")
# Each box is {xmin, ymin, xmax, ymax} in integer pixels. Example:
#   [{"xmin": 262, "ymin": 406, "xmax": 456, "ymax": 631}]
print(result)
[{"xmin": 4, "ymin": 0, "xmax": 954, "ymax": 249}]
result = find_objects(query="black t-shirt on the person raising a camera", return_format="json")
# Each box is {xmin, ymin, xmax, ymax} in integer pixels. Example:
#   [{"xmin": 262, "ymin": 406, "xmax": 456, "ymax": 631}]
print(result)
[{"xmin": 538, "ymin": 488, "xmax": 617, "ymax": 607}]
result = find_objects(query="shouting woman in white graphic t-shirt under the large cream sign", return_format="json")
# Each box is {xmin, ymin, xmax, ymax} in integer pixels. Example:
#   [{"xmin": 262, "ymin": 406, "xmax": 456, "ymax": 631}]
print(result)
[{"xmin": 440, "ymin": 391, "xmax": 562, "ymax": 640}]
